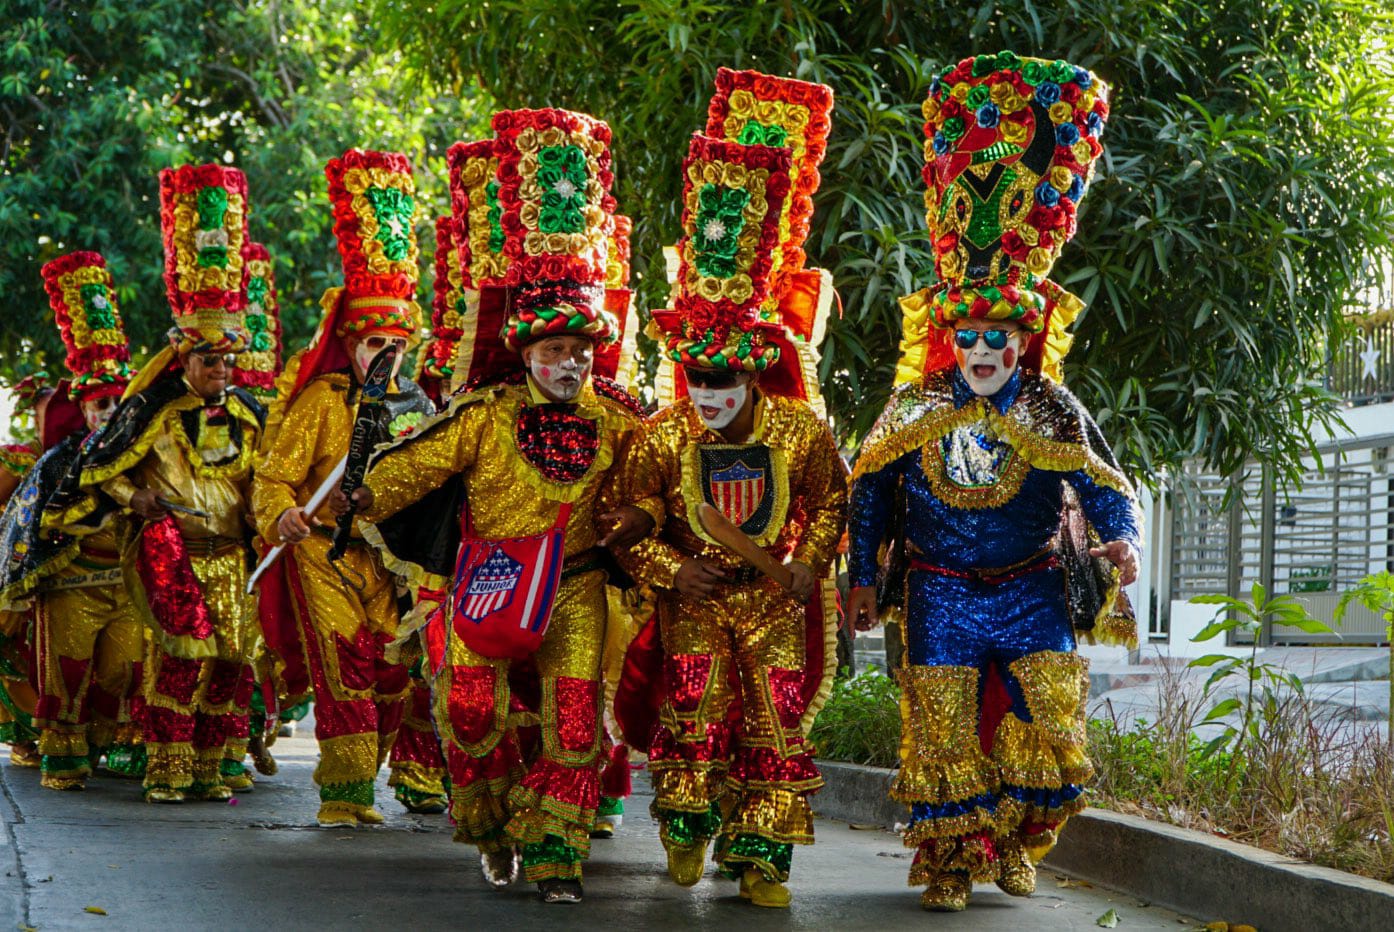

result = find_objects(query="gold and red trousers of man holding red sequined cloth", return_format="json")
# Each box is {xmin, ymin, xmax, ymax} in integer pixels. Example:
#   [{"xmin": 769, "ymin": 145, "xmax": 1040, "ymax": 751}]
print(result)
[{"xmin": 141, "ymin": 546, "xmax": 256, "ymax": 793}]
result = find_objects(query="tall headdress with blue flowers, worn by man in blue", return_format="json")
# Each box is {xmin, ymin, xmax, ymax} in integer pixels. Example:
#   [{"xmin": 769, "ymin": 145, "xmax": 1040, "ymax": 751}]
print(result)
[{"xmin": 902, "ymin": 52, "xmax": 1108, "ymax": 378}]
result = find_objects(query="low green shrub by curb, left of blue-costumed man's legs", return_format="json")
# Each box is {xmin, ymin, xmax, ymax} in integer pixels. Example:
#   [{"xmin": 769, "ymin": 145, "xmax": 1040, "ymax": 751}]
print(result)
[{"xmin": 809, "ymin": 670, "xmax": 901, "ymax": 768}]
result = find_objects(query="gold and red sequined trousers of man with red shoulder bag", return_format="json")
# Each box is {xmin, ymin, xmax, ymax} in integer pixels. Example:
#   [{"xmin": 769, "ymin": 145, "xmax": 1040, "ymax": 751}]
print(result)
[{"xmin": 432, "ymin": 573, "xmax": 606, "ymax": 883}]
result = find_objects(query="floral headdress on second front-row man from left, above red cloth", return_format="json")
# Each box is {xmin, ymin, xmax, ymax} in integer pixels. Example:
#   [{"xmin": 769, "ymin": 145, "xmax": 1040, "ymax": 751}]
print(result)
[{"xmin": 160, "ymin": 164, "xmax": 248, "ymax": 352}]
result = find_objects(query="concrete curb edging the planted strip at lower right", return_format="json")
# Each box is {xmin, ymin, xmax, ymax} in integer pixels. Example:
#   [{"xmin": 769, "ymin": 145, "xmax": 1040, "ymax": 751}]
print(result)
[{"xmin": 813, "ymin": 761, "xmax": 1394, "ymax": 932}]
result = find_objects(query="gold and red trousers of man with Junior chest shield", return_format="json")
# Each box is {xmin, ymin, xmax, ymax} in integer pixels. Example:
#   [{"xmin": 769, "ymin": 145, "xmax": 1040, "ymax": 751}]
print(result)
[{"xmin": 648, "ymin": 581, "xmax": 822, "ymax": 882}]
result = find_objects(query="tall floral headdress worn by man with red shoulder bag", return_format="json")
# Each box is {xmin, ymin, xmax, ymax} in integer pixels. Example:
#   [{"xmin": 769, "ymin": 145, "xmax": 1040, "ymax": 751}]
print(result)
[{"xmin": 491, "ymin": 110, "xmax": 615, "ymax": 350}]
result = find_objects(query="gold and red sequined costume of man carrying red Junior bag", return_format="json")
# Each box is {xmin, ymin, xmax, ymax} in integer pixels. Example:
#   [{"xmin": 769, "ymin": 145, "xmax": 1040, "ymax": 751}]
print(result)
[{"xmin": 364, "ymin": 380, "xmax": 641, "ymax": 883}]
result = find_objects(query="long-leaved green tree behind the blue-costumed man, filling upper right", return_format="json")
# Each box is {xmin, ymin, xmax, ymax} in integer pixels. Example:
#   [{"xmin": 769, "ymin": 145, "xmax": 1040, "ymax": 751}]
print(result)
[{"xmin": 376, "ymin": 0, "xmax": 1394, "ymax": 478}]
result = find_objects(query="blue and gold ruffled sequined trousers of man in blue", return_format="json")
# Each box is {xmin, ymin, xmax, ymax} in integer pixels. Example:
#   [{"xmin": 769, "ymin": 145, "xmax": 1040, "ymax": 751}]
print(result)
[{"xmin": 891, "ymin": 570, "xmax": 1093, "ymax": 886}]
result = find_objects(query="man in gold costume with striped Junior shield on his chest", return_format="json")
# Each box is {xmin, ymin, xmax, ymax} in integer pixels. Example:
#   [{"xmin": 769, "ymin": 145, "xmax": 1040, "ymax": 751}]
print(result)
[{"xmin": 604, "ymin": 70, "xmax": 846, "ymax": 907}]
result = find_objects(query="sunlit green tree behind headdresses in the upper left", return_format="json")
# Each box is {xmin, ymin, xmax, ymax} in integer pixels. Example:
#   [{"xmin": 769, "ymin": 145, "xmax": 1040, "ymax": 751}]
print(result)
[{"xmin": 0, "ymin": 0, "xmax": 488, "ymax": 380}]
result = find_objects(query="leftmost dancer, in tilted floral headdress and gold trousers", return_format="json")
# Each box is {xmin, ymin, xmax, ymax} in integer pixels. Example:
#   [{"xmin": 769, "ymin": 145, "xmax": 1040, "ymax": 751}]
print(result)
[{"xmin": 0, "ymin": 252, "xmax": 145, "ymax": 790}]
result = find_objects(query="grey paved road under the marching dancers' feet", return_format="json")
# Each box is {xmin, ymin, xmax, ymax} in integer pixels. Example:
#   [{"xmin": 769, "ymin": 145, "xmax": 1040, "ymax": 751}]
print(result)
[{"xmin": 0, "ymin": 737, "xmax": 1197, "ymax": 932}]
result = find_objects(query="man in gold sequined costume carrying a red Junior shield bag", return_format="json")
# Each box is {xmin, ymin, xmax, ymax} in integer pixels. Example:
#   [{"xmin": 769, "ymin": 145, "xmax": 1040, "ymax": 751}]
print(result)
[{"xmin": 334, "ymin": 110, "xmax": 641, "ymax": 903}]
